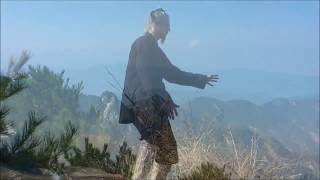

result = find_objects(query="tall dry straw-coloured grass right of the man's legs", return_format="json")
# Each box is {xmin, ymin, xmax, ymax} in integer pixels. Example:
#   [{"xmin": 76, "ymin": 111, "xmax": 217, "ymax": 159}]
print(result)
[{"xmin": 169, "ymin": 105, "xmax": 316, "ymax": 179}]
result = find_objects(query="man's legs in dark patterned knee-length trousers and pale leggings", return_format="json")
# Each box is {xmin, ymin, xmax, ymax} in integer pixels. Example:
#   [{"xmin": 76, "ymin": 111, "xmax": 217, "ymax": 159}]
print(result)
[{"xmin": 133, "ymin": 102, "xmax": 178, "ymax": 180}]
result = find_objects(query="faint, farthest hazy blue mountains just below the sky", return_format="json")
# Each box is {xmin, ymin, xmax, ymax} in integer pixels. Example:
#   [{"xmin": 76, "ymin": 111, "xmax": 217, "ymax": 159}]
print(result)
[{"xmin": 65, "ymin": 64, "xmax": 319, "ymax": 105}]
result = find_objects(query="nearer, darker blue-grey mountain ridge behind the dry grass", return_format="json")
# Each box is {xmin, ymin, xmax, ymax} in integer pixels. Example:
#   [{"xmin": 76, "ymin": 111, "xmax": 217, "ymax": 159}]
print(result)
[{"xmin": 80, "ymin": 91, "xmax": 319, "ymax": 162}]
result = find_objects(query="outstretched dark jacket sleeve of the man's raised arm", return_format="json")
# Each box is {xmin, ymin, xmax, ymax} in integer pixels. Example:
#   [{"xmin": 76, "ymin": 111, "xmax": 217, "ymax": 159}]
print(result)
[{"xmin": 159, "ymin": 49, "xmax": 207, "ymax": 89}]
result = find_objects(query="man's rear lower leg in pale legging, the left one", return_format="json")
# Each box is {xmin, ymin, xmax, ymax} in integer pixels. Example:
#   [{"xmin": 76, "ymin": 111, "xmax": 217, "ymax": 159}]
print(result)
[{"xmin": 132, "ymin": 140, "xmax": 156, "ymax": 180}]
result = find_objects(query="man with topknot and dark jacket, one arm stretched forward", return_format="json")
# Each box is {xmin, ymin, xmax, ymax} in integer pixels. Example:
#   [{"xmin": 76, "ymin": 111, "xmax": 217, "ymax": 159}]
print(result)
[{"xmin": 119, "ymin": 8, "xmax": 218, "ymax": 180}]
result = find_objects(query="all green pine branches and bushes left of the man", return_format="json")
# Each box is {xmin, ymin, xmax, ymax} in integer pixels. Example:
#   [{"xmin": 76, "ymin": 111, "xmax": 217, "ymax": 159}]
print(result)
[{"xmin": 0, "ymin": 52, "xmax": 135, "ymax": 178}]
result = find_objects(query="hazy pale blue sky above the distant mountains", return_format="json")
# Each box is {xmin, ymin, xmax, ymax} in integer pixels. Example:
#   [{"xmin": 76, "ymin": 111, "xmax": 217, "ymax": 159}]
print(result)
[{"xmin": 1, "ymin": 1, "xmax": 319, "ymax": 76}]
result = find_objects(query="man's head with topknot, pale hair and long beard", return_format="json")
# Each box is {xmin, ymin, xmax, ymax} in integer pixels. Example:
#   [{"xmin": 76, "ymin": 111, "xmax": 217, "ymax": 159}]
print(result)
[{"xmin": 145, "ymin": 8, "xmax": 170, "ymax": 43}]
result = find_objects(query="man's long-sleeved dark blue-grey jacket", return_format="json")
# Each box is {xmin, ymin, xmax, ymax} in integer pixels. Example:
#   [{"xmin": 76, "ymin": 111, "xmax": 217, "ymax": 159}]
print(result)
[{"xmin": 119, "ymin": 33, "xmax": 207, "ymax": 124}]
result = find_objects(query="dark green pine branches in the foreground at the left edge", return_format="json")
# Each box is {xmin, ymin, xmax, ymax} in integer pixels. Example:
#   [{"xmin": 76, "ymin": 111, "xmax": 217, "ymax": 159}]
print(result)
[{"xmin": 0, "ymin": 51, "xmax": 77, "ymax": 173}]
